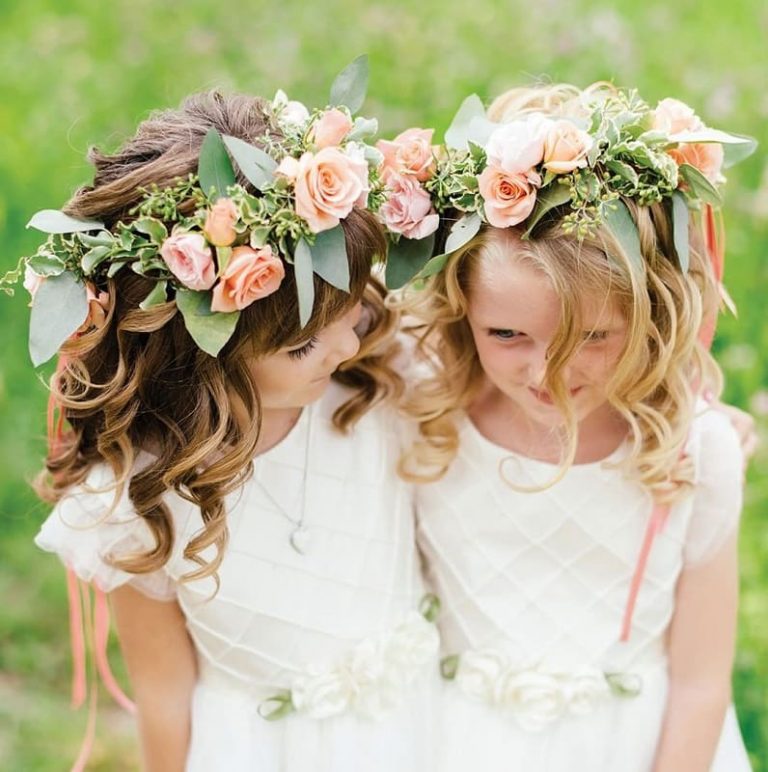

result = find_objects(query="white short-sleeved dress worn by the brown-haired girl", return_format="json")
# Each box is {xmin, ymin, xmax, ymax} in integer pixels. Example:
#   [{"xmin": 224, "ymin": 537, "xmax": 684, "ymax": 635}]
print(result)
[{"xmin": 36, "ymin": 384, "xmax": 439, "ymax": 772}]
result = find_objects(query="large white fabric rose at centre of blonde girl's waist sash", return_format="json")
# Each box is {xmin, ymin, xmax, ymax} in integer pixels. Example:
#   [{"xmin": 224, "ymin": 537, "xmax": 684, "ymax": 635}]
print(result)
[{"xmin": 497, "ymin": 670, "xmax": 567, "ymax": 732}]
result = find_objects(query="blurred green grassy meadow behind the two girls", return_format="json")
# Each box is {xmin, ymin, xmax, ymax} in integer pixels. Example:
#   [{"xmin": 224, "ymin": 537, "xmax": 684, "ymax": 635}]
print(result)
[{"xmin": 0, "ymin": 0, "xmax": 768, "ymax": 772}]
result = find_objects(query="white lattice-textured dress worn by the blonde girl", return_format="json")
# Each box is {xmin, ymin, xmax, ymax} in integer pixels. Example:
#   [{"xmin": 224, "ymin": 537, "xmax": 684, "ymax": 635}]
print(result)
[{"xmin": 417, "ymin": 411, "xmax": 749, "ymax": 772}]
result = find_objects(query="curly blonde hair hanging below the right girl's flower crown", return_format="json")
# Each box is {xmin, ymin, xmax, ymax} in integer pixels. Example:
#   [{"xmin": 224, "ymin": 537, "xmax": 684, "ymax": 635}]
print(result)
[{"xmin": 400, "ymin": 205, "xmax": 721, "ymax": 502}]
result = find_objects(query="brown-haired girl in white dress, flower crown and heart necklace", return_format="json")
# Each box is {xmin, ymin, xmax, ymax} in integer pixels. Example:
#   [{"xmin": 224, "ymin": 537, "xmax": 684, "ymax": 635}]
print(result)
[{"xmin": 15, "ymin": 87, "xmax": 437, "ymax": 772}]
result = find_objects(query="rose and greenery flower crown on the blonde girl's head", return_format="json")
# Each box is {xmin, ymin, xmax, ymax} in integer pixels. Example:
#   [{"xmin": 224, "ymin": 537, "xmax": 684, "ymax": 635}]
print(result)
[{"xmin": 378, "ymin": 85, "xmax": 757, "ymax": 288}]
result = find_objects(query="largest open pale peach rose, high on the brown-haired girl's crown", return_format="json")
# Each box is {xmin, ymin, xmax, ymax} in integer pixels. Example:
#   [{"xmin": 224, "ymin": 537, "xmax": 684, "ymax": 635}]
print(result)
[{"xmin": 291, "ymin": 147, "xmax": 368, "ymax": 233}]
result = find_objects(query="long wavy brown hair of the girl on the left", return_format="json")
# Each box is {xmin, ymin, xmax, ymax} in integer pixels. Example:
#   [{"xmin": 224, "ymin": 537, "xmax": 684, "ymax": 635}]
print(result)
[{"xmin": 35, "ymin": 91, "xmax": 400, "ymax": 580}]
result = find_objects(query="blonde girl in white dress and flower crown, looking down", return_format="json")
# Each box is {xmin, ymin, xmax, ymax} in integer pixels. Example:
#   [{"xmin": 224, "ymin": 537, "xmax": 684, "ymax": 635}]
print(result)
[{"xmin": 396, "ymin": 81, "xmax": 749, "ymax": 772}]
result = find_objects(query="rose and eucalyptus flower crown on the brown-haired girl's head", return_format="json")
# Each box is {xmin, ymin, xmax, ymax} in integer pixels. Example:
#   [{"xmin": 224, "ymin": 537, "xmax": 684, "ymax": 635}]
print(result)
[{"xmin": 0, "ymin": 56, "xmax": 383, "ymax": 366}]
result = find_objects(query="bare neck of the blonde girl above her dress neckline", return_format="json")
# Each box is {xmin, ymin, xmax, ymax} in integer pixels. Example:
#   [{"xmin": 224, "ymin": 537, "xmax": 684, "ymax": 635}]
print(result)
[{"xmin": 467, "ymin": 384, "xmax": 628, "ymax": 464}]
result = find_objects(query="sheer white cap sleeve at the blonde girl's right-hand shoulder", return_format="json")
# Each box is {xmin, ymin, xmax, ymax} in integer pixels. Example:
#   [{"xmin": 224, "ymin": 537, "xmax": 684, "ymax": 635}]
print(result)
[{"xmin": 685, "ymin": 409, "xmax": 743, "ymax": 566}]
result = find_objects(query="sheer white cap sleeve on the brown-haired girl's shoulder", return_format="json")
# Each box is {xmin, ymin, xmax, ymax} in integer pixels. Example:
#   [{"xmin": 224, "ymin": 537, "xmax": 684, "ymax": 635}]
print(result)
[{"xmin": 35, "ymin": 467, "xmax": 176, "ymax": 600}]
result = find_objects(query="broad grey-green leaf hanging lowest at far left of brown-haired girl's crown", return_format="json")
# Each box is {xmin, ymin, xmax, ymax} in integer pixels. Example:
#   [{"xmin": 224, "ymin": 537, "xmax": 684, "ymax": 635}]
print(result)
[{"xmin": 29, "ymin": 271, "xmax": 88, "ymax": 367}]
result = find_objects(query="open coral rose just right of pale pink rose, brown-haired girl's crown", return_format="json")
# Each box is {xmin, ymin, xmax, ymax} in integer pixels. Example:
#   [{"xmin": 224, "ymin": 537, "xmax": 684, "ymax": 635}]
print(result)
[{"xmin": 211, "ymin": 245, "xmax": 285, "ymax": 314}]
